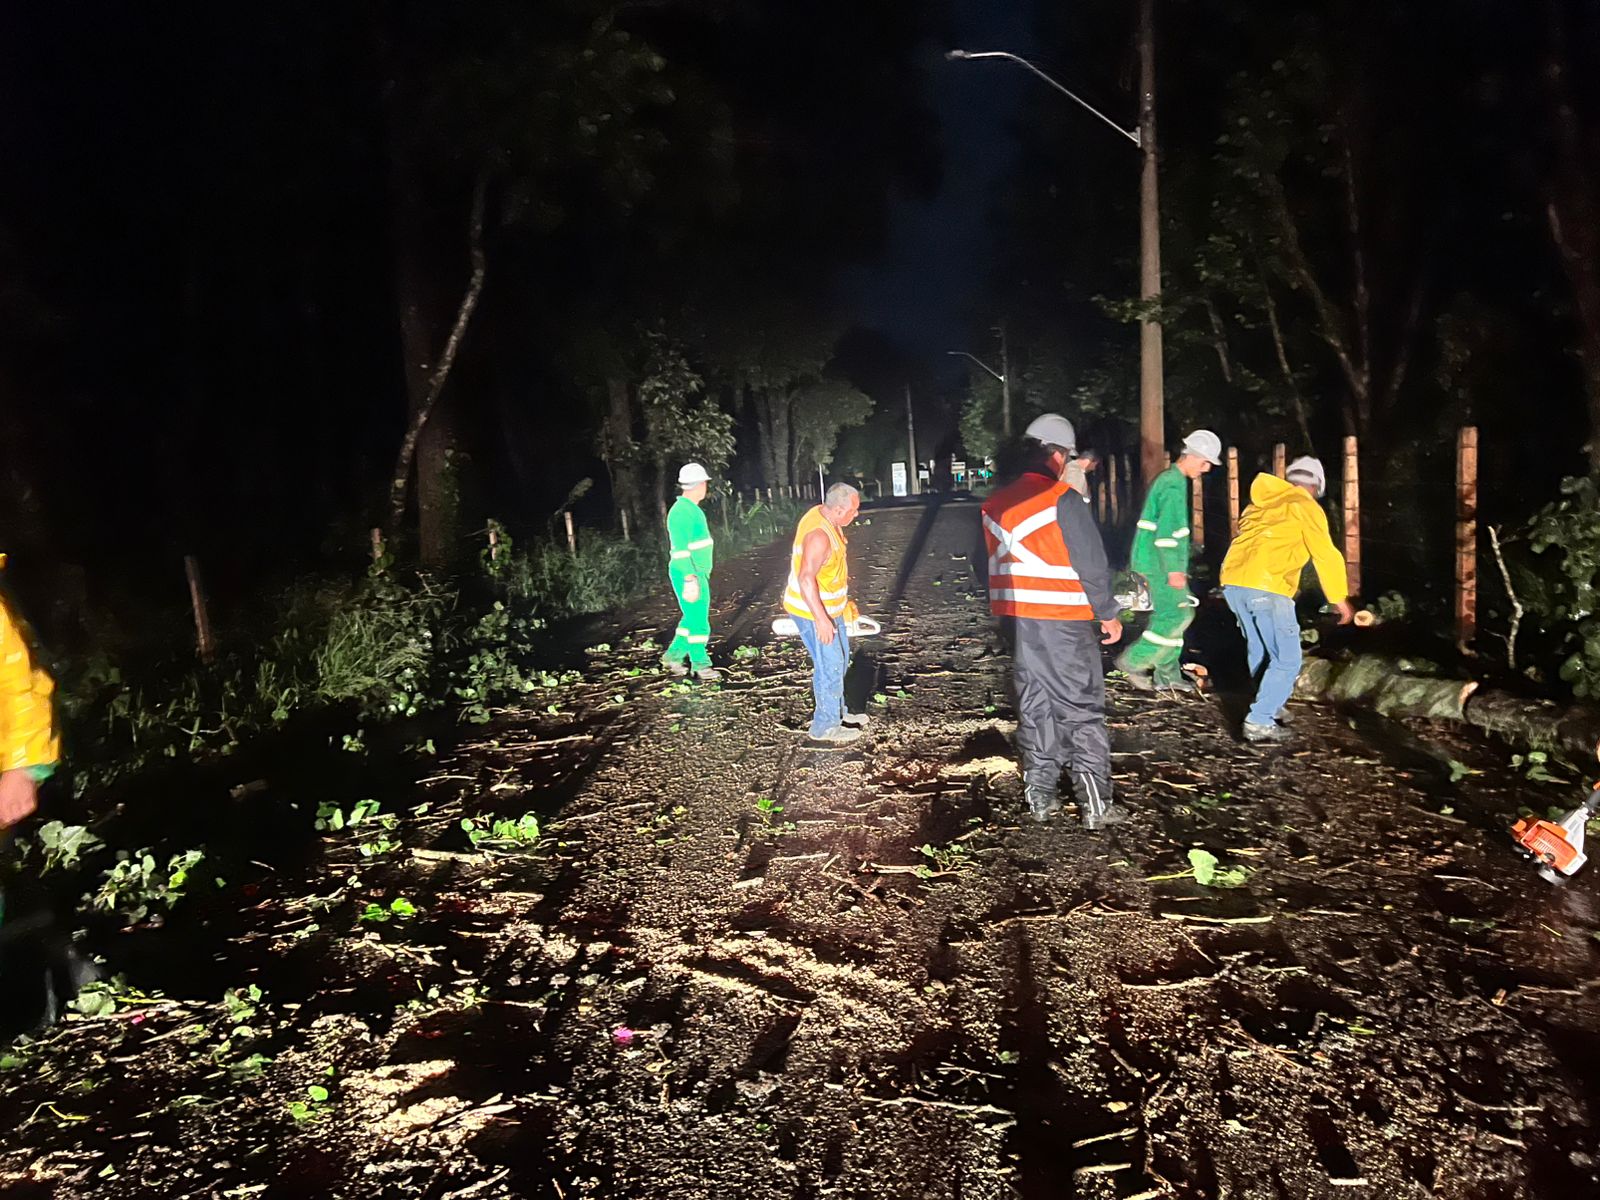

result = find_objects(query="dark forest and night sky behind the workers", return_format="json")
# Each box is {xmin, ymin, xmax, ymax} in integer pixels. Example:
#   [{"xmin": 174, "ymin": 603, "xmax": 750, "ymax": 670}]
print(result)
[{"xmin": 0, "ymin": 0, "xmax": 1600, "ymax": 659}]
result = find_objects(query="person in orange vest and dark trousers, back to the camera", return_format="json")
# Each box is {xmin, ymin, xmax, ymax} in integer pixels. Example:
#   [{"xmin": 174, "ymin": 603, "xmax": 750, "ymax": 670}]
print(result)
[{"xmin": 982, "ymin": 413, "xmax": 1128, "ymax": 829}]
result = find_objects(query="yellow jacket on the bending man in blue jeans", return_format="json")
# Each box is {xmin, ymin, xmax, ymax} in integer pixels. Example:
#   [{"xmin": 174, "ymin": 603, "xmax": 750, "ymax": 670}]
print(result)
[{"xmin": 1222, "ymin": 475, "xmax": 1350, "ymax": 605}]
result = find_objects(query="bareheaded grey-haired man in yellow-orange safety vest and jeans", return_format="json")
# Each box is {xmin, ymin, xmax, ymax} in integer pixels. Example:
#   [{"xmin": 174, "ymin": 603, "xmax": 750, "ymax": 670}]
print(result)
[{"xmin": 784, "ymin": 483, "xmax": 867, "ymax": 744}]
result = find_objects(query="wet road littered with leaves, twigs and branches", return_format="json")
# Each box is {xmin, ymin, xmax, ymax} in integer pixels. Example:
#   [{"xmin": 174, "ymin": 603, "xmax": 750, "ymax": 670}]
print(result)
[{"xmin": 0, "ymin": 504, "xmax": 1600, "ymax": 1200}]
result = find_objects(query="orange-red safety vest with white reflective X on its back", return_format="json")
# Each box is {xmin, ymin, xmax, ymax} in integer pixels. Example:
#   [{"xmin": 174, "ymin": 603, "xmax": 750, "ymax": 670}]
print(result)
[{"xmin": 984, "ymin": 472, "xmax": 1094, "ymax": 621}]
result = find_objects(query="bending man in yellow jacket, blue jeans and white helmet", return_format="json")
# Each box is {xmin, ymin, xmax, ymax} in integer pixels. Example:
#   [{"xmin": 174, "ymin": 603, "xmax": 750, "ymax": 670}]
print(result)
[{"xmin": 1222, "ymin": 458, "xmax": 1355, "ymax": 742}]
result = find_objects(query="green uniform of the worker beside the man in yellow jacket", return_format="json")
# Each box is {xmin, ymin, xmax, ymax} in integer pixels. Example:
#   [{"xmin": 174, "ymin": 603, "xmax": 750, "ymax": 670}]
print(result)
[{"xmin": 1117, "ymin": 467, "xmax": 1195, "ymax": 685}]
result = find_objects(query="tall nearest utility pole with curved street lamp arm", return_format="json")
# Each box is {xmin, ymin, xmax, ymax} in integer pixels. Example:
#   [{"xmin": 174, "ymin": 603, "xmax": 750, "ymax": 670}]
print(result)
[{"xmin": 946, "ymin": 0, "xmax": 1166, "ymax": 485}]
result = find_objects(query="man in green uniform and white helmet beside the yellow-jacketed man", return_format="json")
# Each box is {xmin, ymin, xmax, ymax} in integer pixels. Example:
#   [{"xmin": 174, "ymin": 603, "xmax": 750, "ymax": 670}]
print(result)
[{"xmin": 1117, "ymin": 429, "xmax": 1222, "ymax": 691}]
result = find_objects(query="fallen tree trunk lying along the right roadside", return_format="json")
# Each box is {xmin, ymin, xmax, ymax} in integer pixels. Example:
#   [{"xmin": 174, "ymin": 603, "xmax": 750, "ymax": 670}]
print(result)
[{"xmin": 1294, "ymin": 654, "xmax": 1600, "ymax": 762}]
